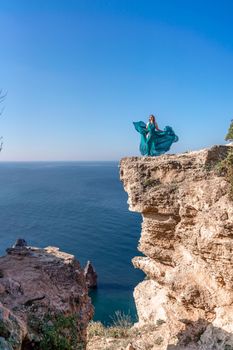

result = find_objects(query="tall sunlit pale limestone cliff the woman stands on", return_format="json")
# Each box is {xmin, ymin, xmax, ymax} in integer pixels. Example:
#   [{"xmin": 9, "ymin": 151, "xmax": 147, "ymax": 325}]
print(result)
[{"xmin": 120, "ymin": 146, "xmax": 233, "ymax": 349}]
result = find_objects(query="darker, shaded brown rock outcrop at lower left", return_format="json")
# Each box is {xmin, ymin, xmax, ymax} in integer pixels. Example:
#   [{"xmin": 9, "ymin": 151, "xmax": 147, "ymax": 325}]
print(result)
[{"xmin": 0, "ymin": 240, "xmax": 93, "ymax": 350}]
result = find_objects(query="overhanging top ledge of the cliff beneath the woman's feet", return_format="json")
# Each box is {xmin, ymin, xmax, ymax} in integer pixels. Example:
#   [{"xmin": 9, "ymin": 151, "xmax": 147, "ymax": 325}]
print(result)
[{"xmin": 120, "ymin": 145, "xmax": 233, "ymax": 213}]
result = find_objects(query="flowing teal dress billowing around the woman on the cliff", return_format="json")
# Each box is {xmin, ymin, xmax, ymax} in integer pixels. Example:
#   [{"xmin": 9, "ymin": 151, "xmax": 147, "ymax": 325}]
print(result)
[{"xmin": 133, "ymin": 121, "xmax": 178, "ymax": 156}]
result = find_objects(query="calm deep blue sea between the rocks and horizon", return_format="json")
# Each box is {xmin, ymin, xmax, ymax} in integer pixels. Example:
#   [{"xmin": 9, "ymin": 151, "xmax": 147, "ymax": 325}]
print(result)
[{"xmin": 0, "ymin": 162, "xmax": 144, "ymax": 324}]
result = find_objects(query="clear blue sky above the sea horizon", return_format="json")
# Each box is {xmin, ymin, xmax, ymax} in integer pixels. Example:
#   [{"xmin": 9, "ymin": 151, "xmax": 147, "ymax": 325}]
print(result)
[{"xmin": 0, "ymin": 0, "xmax": 233, "ymax": 160}]
